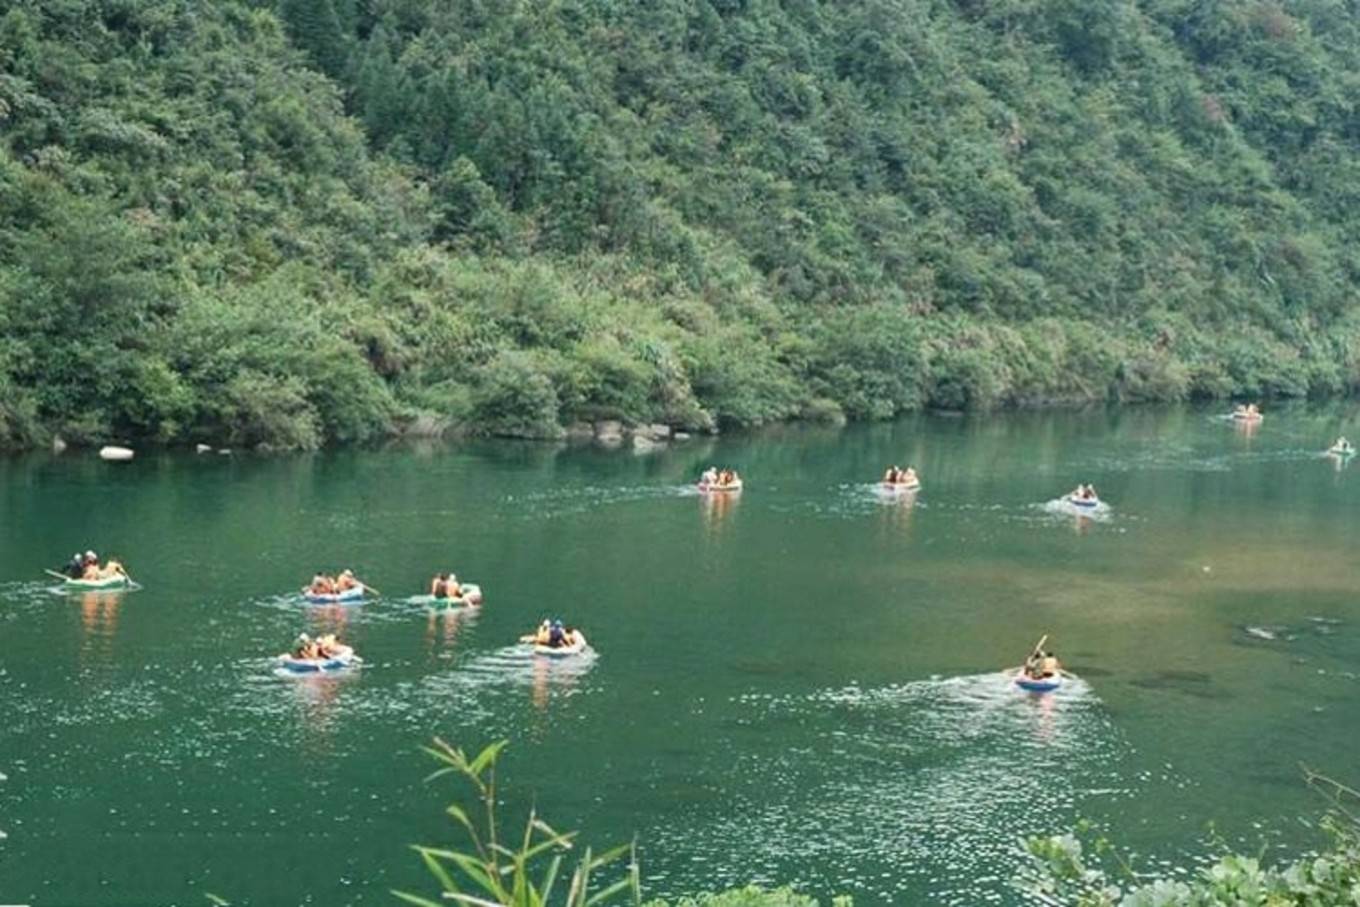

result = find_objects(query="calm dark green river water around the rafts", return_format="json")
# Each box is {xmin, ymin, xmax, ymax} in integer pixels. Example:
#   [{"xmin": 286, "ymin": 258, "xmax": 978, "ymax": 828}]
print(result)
[{"xmin": 0, "ymin": 404, "xmax": 1360, "ymax": 906}]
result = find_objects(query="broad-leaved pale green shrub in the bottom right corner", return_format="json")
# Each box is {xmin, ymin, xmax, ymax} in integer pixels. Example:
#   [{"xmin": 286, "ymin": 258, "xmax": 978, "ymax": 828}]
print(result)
[{"xmin": 1021, "ymin": 774, "xmax": 1360, "ymax": 907}]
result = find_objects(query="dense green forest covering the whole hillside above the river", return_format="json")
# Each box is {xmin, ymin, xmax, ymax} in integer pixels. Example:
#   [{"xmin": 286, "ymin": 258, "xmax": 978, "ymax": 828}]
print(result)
[{"xmin": 0, "ymin": 0, "xmax": 1360, "ymax": 447}]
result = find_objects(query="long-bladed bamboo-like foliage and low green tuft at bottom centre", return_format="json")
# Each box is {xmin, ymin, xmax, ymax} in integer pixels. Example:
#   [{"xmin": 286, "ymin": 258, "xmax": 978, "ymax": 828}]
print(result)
[{"xmin": 393, "ymin": 738, "xmax": 850, "ymax": 907}]
